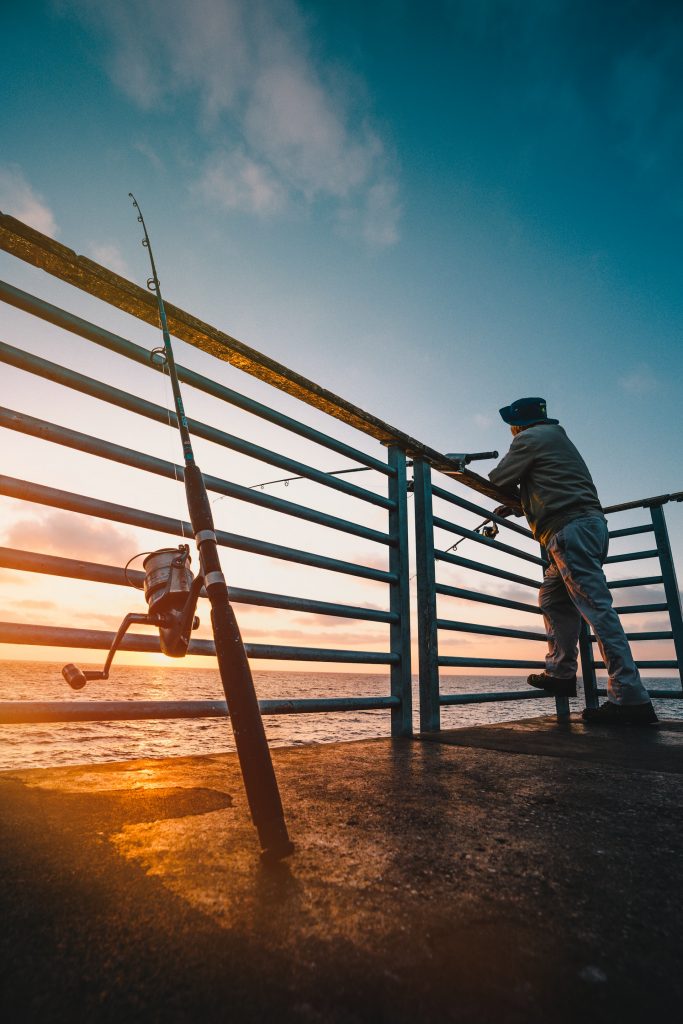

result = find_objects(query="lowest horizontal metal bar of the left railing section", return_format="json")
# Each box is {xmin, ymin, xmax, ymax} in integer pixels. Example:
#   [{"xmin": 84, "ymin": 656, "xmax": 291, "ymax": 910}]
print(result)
[{"xmin": 0, "ymin": 696, "xmax": 400, "ymax": 725}]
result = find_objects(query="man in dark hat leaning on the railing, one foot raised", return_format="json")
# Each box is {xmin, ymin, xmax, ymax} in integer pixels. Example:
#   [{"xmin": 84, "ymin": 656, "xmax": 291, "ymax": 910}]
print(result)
[{"xmin": 488, "ymin": 398, "xmax": 657, "ymax": 725}]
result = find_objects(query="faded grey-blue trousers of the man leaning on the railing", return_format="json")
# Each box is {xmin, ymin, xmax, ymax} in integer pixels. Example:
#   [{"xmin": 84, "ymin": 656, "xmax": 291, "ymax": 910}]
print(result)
[{"xmin": 539, "ymin": 515, "xmax": 650, "ymax": 705}]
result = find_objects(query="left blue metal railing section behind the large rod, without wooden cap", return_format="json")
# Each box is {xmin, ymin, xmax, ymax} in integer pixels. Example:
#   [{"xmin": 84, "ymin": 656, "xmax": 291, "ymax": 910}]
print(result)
[{"xmin": 0, "ymin": 268, "xmax": 412, "ymax": 735}]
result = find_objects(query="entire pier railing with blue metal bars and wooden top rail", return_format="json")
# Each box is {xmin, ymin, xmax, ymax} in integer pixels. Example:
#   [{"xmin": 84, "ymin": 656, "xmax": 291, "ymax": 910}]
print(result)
[{"xmin": 0, "ymin": 214, "xmax": 683, "ymax": 735}]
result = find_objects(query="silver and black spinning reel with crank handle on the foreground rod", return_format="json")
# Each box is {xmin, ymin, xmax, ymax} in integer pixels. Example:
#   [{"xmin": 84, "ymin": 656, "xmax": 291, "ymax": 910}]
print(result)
[{"xmin": 61, "ymin": 544, "xmax": 204, "ymax": 690}]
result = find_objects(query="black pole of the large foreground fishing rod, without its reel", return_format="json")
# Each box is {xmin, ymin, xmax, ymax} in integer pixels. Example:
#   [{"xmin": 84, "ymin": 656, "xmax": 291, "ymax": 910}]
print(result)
[{"xmin": 129, "ymin": 193, "xmax": 294, "ymax": 860}]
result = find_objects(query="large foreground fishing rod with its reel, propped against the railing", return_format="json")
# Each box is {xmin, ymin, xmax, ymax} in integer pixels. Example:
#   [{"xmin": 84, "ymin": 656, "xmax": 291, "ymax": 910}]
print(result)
[{"xmin": 62, "ymin": 193, "xmax": 294, "ymax": 860}]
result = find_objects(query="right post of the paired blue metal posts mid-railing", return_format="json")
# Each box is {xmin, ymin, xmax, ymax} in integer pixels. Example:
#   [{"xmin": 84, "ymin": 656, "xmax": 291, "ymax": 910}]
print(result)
[{"xmin": 414, "ymin": 459, "xmax": 441, "ymax": 732}]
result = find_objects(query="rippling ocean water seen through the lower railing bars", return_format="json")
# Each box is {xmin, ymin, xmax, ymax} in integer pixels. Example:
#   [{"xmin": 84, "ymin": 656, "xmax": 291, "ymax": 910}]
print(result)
[{"xmin": 0, "ymin": 662, "xmax": 683, "ymax": 770}]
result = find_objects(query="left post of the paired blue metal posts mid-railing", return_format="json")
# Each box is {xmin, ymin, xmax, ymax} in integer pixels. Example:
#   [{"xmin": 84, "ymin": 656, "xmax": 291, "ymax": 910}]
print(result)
[{"xmin": 389, "ymin": 445, "xmax": 413, "ymax": 736}]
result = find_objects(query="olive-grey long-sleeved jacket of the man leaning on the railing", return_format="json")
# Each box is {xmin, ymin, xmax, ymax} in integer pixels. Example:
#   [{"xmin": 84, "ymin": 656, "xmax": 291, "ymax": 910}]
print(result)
[{"xmin": 488, "ymin": 423, "xmax": 602, "ymax": 545}]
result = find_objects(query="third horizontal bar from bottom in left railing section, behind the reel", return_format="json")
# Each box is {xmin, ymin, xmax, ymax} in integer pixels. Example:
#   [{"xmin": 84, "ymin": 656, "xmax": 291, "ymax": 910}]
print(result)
[{"xmin": 0, "ymin": 547, "xmax": 398, "ymax": 623}]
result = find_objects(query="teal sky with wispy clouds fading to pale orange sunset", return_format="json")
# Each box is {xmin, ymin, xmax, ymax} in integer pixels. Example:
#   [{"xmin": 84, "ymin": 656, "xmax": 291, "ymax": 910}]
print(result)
[{"xmin": 0, "ymin": 0, "xmax": 683, "ymax": 668}]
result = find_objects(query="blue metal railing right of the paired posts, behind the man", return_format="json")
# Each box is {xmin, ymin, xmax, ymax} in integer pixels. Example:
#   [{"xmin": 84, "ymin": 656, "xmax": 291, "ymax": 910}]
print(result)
[{"xmin": 414, "ymin": 459, "xmax": 683, "ymax": 732}]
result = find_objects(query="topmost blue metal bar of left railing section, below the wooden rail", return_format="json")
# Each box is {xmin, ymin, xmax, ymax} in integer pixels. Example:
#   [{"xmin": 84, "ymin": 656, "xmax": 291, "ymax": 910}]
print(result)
[{"xmin": 0, "ymin": 281, "xmax": 395, "ymax": 476}]
